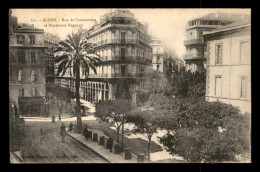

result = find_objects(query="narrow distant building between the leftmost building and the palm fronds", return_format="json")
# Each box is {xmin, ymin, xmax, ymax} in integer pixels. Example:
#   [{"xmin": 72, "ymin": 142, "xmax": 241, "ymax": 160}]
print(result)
[{"xmin": 44, "ymin": 32, "xmax": 60, "ymax": 83}]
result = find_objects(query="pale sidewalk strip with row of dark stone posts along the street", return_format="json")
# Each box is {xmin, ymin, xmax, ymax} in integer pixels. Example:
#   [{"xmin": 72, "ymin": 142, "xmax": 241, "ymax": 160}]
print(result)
[{"xmin": 67, "ymin": 129, "xmax": 137, "ymax": 163}]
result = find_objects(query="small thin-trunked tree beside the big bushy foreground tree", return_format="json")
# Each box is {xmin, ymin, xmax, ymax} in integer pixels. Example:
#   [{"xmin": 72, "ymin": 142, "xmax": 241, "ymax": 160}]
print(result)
[{"xmin": 126, "ymin": 109, "xmax": 162, "ymax": 161}]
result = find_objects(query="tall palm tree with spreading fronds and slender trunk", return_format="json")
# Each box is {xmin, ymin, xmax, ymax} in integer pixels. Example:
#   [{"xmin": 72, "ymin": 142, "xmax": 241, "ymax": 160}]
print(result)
[{"xmin": 54, "ymin": 32, "xmax": 101, "ymax": 132}]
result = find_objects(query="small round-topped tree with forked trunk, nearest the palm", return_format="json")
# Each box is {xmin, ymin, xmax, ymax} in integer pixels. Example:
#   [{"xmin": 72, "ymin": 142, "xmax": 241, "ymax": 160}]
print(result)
[{"xmin": 95, "ymin": 99, "xmax": 132, "ymax": 147}]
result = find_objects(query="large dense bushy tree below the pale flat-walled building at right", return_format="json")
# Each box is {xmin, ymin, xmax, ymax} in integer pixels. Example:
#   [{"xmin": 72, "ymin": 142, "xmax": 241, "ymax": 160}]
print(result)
[{"xmin": 161, "ymin": 98, "xmax": 250, "ymax": 162}]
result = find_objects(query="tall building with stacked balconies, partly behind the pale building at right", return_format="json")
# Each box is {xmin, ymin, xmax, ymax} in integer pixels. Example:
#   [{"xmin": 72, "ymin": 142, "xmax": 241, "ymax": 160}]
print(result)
[{"xmin": 184, "ymin": 12, "xmax": 249, "ymax": 72}]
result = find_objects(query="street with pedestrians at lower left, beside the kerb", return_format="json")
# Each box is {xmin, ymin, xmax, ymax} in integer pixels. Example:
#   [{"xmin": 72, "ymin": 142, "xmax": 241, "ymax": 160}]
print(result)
[{"xmin": 22, "ymin": 122, "xmax": 107, "ymax": 163}]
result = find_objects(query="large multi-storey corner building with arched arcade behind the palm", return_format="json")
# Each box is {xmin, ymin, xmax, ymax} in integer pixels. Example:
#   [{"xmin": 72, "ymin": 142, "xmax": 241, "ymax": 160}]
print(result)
[{"xmin": 55, "ymin": 10, "xmax": 152, "ymax": 104}]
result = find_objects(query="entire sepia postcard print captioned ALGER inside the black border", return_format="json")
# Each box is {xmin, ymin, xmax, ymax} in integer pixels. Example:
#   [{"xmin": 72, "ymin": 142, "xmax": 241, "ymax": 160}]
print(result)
[{"xmin": 8, "ymin": 8, "xmax": 252, "ymax": 164}]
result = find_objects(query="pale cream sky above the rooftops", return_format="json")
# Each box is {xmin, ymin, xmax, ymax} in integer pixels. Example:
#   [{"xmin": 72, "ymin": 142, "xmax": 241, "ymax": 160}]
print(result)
[{"xmin": 12, "ymin": 8, "xmax": 251, "ymax": 59}]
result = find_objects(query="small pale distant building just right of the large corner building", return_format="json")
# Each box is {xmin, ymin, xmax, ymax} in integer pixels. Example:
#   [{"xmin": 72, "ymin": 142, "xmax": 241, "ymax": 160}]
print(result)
[{"xmin": 150, "ymin": 38, "xmax": 183, "ymax": 72}]
